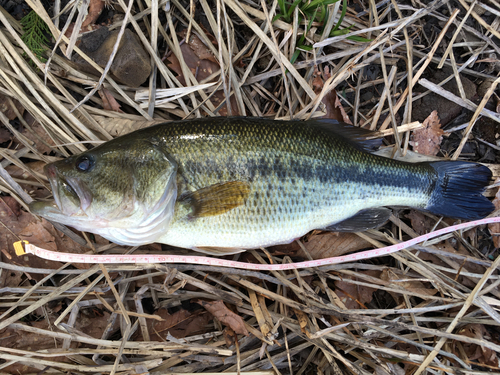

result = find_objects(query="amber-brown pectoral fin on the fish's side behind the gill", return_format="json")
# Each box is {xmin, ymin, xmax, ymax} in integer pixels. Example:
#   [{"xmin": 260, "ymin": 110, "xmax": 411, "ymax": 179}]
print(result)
[{"xmin": 180, "ymin": 181, "xmax": 250, "ymax": 218}]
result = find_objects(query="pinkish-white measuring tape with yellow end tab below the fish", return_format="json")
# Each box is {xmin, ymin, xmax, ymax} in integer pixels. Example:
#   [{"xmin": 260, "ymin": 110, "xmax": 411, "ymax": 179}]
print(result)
[{"xmin": 14, "ymin": 217, "xmax": 500, "ymax": 271}]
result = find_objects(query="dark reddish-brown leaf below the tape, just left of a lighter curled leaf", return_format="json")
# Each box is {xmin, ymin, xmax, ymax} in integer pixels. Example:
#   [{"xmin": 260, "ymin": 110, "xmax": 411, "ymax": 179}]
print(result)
[{"xmin": 148, "ymin": 308, "xmax": 211, "ymax": 341}]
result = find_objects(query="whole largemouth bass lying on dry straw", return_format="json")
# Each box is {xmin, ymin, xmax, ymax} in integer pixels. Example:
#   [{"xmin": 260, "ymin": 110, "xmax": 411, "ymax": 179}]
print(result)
[{"xmin": 29, "ymin": 117, "xmax": 494, "ymax": 255}]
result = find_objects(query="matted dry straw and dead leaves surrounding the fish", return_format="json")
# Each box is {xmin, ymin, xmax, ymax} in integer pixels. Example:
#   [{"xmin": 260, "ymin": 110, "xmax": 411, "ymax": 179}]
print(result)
[{"xmin": 0, "ymin": 0, "xmax": 500, "ymax": 375}]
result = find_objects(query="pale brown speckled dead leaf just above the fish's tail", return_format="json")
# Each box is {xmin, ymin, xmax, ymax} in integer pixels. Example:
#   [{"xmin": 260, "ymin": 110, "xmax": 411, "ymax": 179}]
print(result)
[{"xmin": 410, "ymin": 111, "xmax": 444, "ymax": 156}]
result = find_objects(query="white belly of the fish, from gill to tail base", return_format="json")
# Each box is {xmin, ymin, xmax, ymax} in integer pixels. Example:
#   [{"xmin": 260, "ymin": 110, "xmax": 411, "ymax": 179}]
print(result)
[{"xmin": 157, "ymin": 189, "xmax": 424, "ymax": 254}]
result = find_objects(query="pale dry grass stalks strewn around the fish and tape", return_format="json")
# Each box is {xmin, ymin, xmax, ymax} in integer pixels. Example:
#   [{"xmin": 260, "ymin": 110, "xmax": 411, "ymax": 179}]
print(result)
[{"xmin": 0, "ymin": 0, "xmax": 500, "ymax": 375}]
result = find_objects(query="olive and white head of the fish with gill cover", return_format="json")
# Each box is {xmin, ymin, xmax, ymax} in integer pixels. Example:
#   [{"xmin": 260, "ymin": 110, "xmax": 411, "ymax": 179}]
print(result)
[{"xmin": 30, "ymin": 139, "xmax": 177, "ymax": 245}]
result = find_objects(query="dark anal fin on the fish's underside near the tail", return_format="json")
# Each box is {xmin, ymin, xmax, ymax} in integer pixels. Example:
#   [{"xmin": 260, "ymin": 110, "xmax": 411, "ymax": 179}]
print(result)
[{"xmin": 325, "ymin": 207, "xmax": 392, "ymax": 232}]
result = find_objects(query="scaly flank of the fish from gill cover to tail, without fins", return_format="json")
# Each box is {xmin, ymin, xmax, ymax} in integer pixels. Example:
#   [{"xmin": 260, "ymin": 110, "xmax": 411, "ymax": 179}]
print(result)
[{"xmin": 148, "ymin": 120, "xmax": 430, "ymax": 248}]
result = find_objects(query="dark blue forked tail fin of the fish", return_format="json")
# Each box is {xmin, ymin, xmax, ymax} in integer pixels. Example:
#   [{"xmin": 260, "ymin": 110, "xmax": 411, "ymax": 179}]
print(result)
[{"xmin": 426, "ymin": 161, "xmax": 495, "ymax": 220}]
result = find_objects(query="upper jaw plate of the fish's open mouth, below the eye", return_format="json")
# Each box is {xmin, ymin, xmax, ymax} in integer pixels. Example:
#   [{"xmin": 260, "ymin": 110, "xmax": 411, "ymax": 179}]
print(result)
[{"xmin": 44, "ymin": 164, "xmax": 92, "ymax": 216}]
